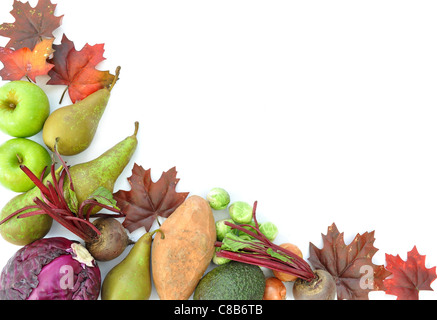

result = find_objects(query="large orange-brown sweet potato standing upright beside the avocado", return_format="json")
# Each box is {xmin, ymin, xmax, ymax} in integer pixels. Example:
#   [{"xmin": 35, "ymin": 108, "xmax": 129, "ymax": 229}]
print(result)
[{"xmin": 152, "ymin": 196, "xmax": 216, "ymax": 300}]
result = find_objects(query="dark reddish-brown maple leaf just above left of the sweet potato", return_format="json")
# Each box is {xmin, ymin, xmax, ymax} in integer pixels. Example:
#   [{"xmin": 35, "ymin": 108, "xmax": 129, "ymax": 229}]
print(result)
[{"xmin": 114, "ymin": 163, "xmax": 188, "ymax": 232}]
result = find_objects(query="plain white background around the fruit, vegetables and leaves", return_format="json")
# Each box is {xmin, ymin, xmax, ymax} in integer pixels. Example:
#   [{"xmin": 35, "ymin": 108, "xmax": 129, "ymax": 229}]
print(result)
[{"xmin": 0, "ymin": 0, "xmax": 437, "ymax": 299}]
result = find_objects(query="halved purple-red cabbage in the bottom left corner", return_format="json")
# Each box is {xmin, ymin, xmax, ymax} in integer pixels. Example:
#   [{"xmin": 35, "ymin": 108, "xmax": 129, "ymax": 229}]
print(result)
[{"xmin": 0, "ymin": 237, "xmax": 101, "ymax": 300}]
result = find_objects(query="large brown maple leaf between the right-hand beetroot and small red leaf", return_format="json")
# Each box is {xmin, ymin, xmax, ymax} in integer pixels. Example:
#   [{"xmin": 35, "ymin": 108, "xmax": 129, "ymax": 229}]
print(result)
[{"xmin": 308, "ymin": 223, "xmax": 390, "ymax": 300}]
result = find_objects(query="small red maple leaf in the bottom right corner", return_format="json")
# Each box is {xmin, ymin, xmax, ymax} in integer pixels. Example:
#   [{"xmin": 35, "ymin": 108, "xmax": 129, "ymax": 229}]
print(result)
[{"xmin": 384, "ymin": 246, "xmax": 437, "ymax": 300}]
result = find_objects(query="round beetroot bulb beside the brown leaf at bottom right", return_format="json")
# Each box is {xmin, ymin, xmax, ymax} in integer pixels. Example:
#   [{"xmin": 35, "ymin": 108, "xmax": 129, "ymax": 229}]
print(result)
[{"xmin": 293, "ymin": 270, "xmax": 337, "ymax": 300}]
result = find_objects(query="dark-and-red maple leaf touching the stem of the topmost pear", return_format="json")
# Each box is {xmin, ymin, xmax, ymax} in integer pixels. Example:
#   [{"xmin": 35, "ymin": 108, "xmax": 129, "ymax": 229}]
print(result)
[{"xmin": 47, "ymin": 34, "xmax": 114, "ymax": 103}]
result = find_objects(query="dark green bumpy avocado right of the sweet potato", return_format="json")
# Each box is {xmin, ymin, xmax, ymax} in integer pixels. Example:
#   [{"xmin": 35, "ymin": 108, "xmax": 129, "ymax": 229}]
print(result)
[{"xmin": 193, "ymin": 261, "xmax": 266, "ymax": 300}]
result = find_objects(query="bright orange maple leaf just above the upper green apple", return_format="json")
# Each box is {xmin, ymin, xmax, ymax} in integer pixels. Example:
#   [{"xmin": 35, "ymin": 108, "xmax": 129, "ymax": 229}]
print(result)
[{"xmin": 0, "ymin": 38, "xmax": 54, "ymax": 82}]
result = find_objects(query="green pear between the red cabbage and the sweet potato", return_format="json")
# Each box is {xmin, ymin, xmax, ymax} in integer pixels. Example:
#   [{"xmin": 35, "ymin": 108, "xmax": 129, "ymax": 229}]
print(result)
[{"xmin": 101, "ymin": 229, "xmax": 164, "ymax": 300}]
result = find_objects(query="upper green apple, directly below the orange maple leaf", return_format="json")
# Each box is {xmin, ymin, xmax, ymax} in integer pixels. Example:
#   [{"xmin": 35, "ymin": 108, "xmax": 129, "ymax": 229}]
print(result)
[{"xmin": 0, "ymin": 80, "xmax": 50, "ymax": 138}]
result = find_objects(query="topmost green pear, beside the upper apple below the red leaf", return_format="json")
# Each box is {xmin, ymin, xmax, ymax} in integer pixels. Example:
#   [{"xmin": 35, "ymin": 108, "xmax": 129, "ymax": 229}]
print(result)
[{"xmin": 42, "ymin": 67, "xmax": 120, "ymax": 156}]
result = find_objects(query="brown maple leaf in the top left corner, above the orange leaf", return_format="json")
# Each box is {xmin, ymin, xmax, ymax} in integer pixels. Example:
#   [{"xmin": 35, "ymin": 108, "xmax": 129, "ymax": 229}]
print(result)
[{"xmin": 0, "ymin": 0, "xmax": 63, "ymax": 50}]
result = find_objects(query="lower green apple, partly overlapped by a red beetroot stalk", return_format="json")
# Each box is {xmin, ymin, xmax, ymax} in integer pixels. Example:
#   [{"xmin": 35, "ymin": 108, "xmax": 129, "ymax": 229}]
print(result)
[{"xmin": 0, "ymin": 138, "xmax": 52, "ymax": 192}]
